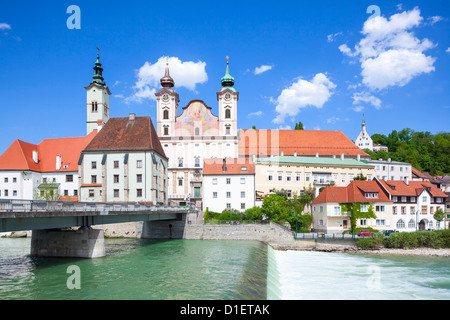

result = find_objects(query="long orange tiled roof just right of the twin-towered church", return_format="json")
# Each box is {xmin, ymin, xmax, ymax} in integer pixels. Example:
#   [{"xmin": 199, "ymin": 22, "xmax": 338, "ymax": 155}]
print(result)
[{"xmin": 238, "ymin": 129, "xmax": 369, "ymax": 157}]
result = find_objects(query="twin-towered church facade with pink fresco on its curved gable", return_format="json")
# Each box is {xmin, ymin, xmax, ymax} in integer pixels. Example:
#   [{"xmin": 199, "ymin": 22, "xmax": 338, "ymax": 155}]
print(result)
[{"xmin": 155, "ymin": 57, "xmax": 239, "ymax": 208}]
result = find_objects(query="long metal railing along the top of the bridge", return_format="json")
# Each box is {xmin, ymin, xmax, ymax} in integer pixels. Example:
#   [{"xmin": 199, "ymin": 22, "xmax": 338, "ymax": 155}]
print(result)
[{"xmin": 0, "ymin": 199, "xmax": 192, "ymax": 213}]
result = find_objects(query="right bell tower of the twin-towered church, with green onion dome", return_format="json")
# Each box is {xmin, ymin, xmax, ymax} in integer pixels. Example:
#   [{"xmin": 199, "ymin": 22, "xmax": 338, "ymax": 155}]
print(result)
[{"xmin": 217, "ymin": 56, "xmax": 239, "ymax": 136}]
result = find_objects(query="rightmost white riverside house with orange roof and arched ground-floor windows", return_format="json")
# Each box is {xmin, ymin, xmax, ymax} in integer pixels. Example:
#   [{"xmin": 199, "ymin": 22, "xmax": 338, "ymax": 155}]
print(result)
[{"xmin": 376, "ymin": 179, "xmax": 447, "ymax": 231}]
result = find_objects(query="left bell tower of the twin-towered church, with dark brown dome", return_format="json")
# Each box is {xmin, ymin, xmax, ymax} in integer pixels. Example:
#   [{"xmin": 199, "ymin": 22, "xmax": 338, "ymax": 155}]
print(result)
[{"xmin": 155, "ymin": 57, "xmax": 180, "ymax": 137}]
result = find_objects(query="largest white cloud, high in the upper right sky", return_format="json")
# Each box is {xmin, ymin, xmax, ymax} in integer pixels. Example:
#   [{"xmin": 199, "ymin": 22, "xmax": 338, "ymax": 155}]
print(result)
[{"xmin": 339, "ymin": 7, "xmax": 436, "ymax": 90}]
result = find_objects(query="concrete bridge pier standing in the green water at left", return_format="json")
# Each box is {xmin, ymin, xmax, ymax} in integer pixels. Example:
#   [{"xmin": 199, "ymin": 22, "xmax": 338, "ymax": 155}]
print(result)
[{"xmin": 31, "ymin": 227, "xmax": 106, "ymax": 259}]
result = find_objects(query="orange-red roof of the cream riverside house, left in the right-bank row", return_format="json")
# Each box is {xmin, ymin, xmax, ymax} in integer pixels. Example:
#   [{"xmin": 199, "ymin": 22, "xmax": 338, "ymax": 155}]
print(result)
[{"xmin": 313, "ymin": 180, "xmax": 392, "ymax": 204}]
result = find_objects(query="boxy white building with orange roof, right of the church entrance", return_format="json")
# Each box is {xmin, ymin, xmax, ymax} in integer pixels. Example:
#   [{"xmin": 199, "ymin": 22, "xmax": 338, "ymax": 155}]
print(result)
[{"xmin": 203, "ymin": 158, "xmax": 255, "ymax": 212}]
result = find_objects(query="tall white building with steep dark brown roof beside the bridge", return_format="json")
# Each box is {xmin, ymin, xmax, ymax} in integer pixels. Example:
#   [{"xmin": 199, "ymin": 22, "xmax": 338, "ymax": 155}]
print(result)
[{"xmin": 79, "ymin": 114, "xmax": 168, "ymax": 204}]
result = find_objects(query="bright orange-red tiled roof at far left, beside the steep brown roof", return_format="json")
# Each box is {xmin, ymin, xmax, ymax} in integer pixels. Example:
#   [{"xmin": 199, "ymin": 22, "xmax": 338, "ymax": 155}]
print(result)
[{"xmin": 0, "ymin": 130, "xmax": 97, "ymax": 172}]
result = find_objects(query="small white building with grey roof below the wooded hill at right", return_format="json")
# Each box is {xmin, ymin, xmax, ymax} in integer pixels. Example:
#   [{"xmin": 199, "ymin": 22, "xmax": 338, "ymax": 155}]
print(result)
[{"xmin": 368, "ymin": 159, "xmax": 412, "ymax": 182}]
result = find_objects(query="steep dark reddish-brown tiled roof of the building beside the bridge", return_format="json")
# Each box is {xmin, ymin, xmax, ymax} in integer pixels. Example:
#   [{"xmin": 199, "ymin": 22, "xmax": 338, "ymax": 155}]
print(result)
[{"xmin": 84, "ymin": 116, "xmax": 167, "ymax": 158}]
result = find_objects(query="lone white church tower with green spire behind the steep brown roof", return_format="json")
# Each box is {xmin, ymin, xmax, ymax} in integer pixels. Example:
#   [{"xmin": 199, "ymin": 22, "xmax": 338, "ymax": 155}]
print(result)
[{"xmin": 85, "ymin": 48, "xmax": 111, "ymax": 134}]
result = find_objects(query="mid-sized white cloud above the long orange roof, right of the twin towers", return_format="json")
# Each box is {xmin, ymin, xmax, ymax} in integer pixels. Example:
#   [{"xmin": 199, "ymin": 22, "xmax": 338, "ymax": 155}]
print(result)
[{"xmin": 272, "ymin": 73, "xmax": 336, "ymax": 124}]
